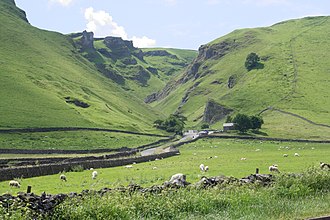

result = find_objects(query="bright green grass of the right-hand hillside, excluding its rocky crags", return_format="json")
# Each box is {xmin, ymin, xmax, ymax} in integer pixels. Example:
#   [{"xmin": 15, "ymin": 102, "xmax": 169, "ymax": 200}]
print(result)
[{"xmin": 154, "ymin": 17, "xmax": 330, "ymax": 138}]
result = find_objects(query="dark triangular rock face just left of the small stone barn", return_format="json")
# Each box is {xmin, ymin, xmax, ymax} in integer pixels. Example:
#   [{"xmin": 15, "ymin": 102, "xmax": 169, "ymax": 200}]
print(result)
[{"xmin": 203, "ymin": 100, "xmax": 233, "ymax": 124}]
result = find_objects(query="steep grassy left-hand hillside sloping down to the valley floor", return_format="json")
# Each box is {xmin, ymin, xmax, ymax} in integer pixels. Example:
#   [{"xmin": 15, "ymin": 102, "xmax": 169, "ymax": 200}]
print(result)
[{"xmin": 0, "ymin": 0, "xmax": 163, "ymax": 132}]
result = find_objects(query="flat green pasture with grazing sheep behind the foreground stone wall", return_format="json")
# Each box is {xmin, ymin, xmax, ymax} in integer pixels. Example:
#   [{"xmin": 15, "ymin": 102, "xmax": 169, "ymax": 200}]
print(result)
[{"xmin": 0, "ymin": 139, "xmax": 330, "ymax": 194}]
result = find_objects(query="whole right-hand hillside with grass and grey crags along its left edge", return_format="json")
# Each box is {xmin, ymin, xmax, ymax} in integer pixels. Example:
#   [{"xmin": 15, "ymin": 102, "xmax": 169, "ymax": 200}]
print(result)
[{"xmin": 151, "ymin": 17, "xmax": 330, "ymax": 136}]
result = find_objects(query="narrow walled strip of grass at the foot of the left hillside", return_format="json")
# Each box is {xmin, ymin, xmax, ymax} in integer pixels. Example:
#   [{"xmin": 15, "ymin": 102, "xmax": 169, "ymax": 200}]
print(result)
[{"xmin": 0, "ymin": 131, "xmax": 161, "ymax": 151}]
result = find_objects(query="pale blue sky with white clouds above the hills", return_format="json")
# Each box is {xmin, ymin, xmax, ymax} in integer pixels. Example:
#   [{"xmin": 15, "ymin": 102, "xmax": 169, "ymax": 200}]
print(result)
[{"xmin": 15, "ymin": 0, "xmax": 330, "ymax": 50}]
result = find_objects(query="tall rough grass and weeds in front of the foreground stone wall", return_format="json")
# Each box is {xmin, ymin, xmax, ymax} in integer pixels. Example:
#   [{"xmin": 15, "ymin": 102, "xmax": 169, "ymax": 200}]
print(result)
[{"xmin": 3, "ymin": 170, "xmax": 330, "ymax": 219}]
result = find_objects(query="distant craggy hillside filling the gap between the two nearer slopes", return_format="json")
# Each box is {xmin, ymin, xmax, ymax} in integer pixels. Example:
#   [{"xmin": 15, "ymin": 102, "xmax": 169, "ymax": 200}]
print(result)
[{"xmin": 70, "ymin": 31, "xmax": 197, "ymax": 100}]
